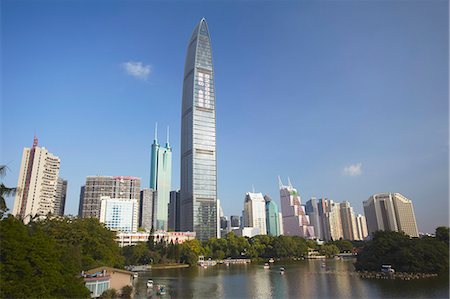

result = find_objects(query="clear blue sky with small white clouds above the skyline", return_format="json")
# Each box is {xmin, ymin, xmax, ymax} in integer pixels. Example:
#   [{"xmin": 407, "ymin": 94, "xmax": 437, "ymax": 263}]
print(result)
[{"xmin": 1, "ymin": 0, "xmax": 449, "ymax": 232}]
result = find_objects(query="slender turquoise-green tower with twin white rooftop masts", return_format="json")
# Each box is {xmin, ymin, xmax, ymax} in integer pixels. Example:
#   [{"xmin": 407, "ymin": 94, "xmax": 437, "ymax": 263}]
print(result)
[{"xmin": 150, "ymin": 128, "xmax": 172, "ymax": 231}]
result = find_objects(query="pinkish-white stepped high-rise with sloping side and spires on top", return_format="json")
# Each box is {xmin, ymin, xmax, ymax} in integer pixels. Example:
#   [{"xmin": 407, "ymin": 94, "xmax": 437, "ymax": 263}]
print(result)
[{"xmin": 279, "ymin": 179, "xmax": 315, "ymax": 238}]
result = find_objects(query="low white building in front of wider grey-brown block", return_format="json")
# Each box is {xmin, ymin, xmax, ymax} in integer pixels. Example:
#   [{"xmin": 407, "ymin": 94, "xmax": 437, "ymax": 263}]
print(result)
[{"xmin": 100, "ymin": 196, "xmax": 139, "ymax": 232}]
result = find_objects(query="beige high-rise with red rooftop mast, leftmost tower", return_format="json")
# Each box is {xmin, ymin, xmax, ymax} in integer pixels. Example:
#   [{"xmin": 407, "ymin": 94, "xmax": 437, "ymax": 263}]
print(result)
[{"xmin": 13, "ymin": 136, "xmax": 61, "ymax": 224}]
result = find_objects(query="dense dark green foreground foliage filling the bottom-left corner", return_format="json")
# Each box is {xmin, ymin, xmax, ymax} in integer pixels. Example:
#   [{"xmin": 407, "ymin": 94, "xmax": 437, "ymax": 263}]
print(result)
[{"xmin": 0, "ymin": 215, "xmax": 89, "ymax": 298}]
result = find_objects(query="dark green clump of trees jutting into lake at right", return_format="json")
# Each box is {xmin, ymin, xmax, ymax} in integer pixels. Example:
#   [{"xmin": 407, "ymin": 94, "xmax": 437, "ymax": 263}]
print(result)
[{"xmin": 355, "ymin": 228, "xmax": 449, "ymax": 273}]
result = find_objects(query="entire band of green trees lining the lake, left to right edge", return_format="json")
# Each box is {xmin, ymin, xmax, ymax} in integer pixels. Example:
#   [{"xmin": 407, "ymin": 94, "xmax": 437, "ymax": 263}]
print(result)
[{"xmin": 0, "ymin": 214, "xmax": 449, "ymax": 298}]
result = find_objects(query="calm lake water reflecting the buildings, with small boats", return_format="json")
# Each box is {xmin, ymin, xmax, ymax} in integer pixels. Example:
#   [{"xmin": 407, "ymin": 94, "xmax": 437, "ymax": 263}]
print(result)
[{"xmin": 135, "ymin": 260, "xmax": 449, "ymax": 298}]
